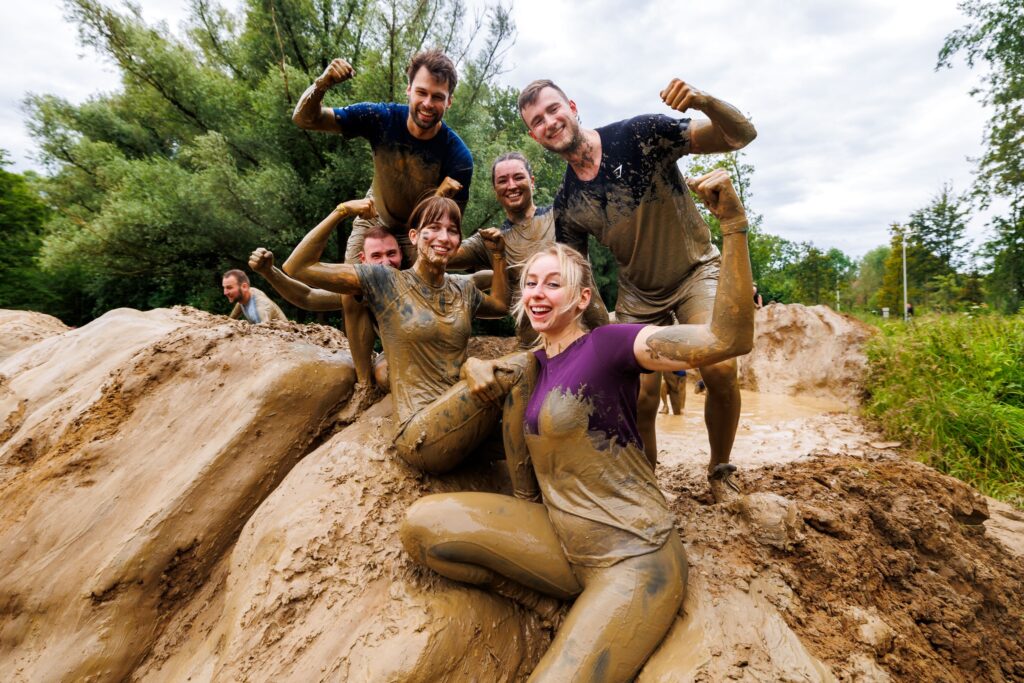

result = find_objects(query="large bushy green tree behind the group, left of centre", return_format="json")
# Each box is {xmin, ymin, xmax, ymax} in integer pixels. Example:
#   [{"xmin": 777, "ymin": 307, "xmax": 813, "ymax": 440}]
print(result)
[{"xmin": 27, "ymin": 0, "xmax": 528, "ymax": 323}]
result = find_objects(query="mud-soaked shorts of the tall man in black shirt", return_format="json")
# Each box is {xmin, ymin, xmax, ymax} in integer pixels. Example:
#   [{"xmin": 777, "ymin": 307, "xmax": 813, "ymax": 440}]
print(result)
[{"xmin": 615, "ymin": 257, "xmax": 721, "ymax": 325}]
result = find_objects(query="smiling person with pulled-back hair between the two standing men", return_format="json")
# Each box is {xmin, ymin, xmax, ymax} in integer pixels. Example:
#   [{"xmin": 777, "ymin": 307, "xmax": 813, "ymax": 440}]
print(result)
[{"xmin": 449, "ymin": 152, "xmax": 608, "ymax": 349}]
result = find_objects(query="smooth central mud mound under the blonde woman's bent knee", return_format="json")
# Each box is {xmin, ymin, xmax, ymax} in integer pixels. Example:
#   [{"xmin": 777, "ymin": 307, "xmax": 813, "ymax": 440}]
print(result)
[{"xmin": 133, "ymin": 399, "xmax": 549, "ymax": 683}]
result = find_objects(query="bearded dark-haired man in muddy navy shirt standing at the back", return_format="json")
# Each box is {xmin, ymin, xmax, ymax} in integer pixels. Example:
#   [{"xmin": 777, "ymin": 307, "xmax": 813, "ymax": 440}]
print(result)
[{"xmin": 292, "ymin": 50, "xmax": 473, "ymax": 393}]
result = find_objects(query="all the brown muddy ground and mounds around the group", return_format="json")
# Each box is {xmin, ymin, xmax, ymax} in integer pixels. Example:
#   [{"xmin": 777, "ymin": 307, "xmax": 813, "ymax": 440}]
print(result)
[{"xmin": 0, "ymin": 306, "xmax": 1024, "ymax": 682}]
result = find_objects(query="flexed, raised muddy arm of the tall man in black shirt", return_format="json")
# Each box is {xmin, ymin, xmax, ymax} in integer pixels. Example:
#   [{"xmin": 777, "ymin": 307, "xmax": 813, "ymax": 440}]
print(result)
[{"xmin": 662, "ymin": 78, "xmax": 758, "ymax": 155}]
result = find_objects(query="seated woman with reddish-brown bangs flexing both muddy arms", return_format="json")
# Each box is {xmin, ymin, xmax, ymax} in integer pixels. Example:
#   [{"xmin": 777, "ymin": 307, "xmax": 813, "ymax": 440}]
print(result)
[{"xmin": 284, "ymin": 192, "xmax": 524, "ymax": 473}]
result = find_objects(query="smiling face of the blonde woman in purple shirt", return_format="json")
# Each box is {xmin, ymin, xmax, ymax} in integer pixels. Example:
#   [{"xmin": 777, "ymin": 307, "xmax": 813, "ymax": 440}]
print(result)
[{"xmin": 522, "ymin": 253, "xmax": 590, "ymax": 337}]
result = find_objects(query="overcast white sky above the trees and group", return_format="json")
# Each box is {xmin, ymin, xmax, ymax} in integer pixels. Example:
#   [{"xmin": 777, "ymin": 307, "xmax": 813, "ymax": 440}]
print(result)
[{"xmin": 0, "ymin": 0, "xmax": 999, "ymax": 256}]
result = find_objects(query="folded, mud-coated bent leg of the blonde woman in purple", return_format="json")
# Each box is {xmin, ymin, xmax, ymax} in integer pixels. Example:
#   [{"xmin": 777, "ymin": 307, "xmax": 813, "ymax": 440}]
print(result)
[{"xmin": 400, "ymin": 493, "xmax": 581, "ymax": 600}]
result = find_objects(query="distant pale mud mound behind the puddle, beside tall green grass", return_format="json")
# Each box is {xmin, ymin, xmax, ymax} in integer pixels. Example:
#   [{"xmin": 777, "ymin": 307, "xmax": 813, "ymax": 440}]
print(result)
[{"xmin": 739, "ymin": 303, "xmax": 873, "ymax": 402}]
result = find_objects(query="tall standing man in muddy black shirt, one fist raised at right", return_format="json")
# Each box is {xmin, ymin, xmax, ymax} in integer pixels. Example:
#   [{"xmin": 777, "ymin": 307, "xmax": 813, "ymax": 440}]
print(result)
[{"xmin": 518, "ymin": 79, "xmax": 757, "ymax": 502}]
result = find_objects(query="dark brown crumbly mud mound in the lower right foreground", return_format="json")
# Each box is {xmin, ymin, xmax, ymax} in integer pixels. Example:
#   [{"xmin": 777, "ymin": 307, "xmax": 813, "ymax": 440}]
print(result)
[{"xmin": 655, "ymin": 457, "xmax": 1024, "ymax": 681}]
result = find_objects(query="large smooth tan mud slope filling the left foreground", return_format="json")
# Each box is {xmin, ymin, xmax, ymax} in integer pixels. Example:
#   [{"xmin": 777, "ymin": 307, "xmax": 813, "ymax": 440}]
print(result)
[{"xmin": 0, "ymin": 309, "xmax": 354, "ymax": 681}]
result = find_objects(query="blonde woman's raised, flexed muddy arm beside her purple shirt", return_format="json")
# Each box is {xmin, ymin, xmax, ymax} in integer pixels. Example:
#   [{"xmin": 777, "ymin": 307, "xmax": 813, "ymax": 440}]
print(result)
[{"xmin": 633, "ymin": 170, "xmax": 754, "ymax": 371}]
